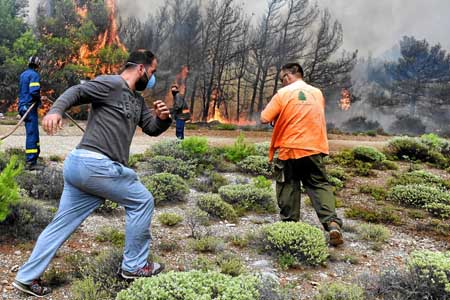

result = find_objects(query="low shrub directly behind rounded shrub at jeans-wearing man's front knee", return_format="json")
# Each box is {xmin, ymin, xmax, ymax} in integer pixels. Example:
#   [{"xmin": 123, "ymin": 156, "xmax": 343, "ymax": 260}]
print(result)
[{"xmin": 147, "ymin": 155, "xmax": 195, "ymax": 179}]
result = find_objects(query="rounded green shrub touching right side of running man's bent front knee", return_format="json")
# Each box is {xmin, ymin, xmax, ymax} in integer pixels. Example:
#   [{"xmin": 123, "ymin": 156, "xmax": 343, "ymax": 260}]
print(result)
[{"xmin": 142, "ymin": 173, "xmax": 189, "ymax": 204}]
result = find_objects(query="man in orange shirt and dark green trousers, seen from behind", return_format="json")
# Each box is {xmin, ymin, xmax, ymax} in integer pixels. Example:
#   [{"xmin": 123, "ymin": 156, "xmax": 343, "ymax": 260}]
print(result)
[{"xmin": 261, "ymin": 63, "xmax": 343, "ymax": 246}]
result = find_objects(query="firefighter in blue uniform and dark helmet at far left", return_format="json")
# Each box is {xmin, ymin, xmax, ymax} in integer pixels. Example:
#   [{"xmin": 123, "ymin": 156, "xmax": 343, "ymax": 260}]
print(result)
[{"xmin": 19, "ymin": 56, "xmax": 41, "ymax": 170}]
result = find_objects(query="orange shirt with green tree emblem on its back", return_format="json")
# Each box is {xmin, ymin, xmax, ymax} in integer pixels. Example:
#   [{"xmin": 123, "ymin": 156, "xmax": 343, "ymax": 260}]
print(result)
[{"xmin": 261, "ymin": 80, "xmax": 329, "ymax": 160}]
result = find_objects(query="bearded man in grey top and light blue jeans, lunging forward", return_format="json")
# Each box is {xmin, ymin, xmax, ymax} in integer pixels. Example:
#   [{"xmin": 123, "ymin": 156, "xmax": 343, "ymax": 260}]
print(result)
[{"xmin": 13, "ymin": 50, "xmax": 172, "ymax": 296}]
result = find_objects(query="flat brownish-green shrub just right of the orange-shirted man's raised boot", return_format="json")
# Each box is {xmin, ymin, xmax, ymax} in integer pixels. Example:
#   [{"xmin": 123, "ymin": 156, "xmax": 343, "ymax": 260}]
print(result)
[{"xmin": 345, "ymin": 205, "xmax": 403, "ymax": 225}]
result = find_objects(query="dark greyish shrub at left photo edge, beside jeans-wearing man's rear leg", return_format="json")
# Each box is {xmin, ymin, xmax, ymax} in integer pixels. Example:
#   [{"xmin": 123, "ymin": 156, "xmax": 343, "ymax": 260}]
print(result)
[{"xmin": 0, "ymin": 199, "xmax": 53, "ymax": 241}]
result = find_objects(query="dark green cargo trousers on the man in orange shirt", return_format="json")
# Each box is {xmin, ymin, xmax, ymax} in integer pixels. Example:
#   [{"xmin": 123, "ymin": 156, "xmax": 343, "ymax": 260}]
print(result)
[{"xmin": 274, "ymin": 154, "xmax": 342, "ymax": 230}]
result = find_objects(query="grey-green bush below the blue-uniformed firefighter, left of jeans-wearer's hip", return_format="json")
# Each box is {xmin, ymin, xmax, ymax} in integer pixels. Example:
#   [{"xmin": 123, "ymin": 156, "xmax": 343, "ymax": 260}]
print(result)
[{"xmin": 17, "ymin": 165, "xmax": 64, "ymax": 201}]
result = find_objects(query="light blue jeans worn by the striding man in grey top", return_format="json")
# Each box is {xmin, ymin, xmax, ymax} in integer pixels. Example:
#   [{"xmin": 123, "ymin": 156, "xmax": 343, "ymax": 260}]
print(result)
[{"xmin": 16, "ymin": 149, "xmax": 154, "ymax": 284}]
